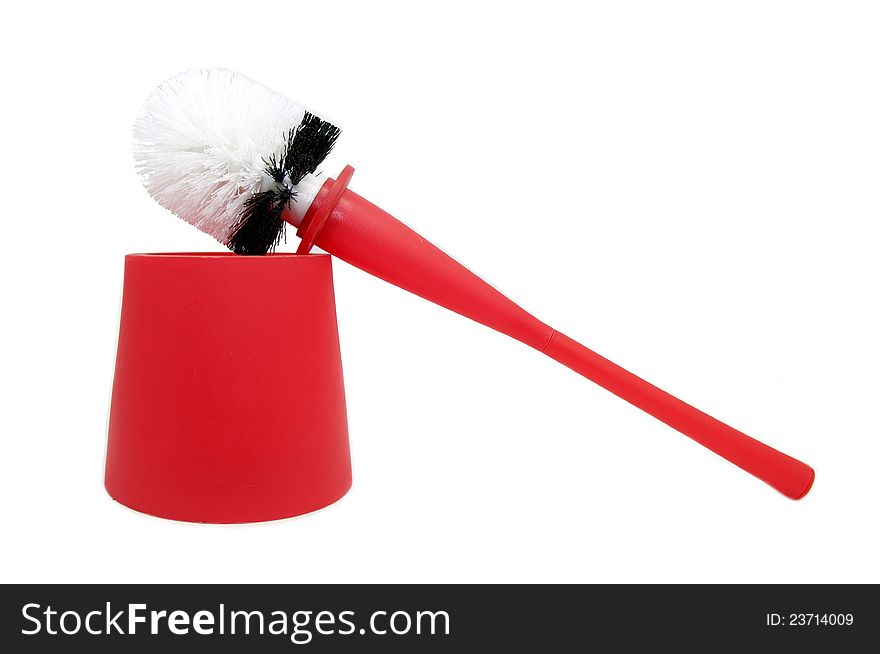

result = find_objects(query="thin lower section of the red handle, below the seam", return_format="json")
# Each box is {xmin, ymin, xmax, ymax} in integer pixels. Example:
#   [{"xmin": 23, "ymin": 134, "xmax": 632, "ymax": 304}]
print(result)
[{"xmin": 543, "ymin": 331, "xmax": 815, "ymax": 500}]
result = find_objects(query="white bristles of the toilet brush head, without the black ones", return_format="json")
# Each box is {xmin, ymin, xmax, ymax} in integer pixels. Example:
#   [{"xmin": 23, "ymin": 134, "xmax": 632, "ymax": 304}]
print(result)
[{"xmin": 134, "ymin": 68, "xmax": 304, "ymax": 244}]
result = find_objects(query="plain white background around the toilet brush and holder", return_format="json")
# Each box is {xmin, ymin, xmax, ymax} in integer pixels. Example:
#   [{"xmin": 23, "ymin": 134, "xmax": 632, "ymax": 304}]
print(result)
[{"xmin": 0, "ymin": 0, "xmax": 880, "ymax": 582}]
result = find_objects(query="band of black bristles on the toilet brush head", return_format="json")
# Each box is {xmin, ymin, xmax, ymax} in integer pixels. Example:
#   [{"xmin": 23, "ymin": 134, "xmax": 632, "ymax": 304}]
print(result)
[{"xmin": 226, "ymin": 111, "xmax": 340, "ymax": 255}]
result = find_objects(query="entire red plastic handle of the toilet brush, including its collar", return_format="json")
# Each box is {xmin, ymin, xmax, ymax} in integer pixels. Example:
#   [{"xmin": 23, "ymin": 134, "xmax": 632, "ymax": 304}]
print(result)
[{"xmin": 298, "ymin": 166, "xmax": 813, "ymax": 499}]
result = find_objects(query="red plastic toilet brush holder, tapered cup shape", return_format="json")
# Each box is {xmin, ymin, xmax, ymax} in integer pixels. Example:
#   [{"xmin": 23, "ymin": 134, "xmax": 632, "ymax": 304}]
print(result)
[{"xmin": 105, "ymin": 253, "xmax": 351, "ymax": 523}]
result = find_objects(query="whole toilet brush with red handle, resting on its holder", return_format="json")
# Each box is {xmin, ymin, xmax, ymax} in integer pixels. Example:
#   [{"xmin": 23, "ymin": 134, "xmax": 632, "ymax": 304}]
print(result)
[{"xmin": 135, "ymin": 69, "xmax": 814, "ymax": 499}]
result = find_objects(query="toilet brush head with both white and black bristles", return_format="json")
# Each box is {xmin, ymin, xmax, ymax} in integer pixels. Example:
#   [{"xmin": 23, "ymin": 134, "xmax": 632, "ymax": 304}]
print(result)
[{"xmin": 134, "ymin": 68, "xmax": 339, "ymax": 255}]
